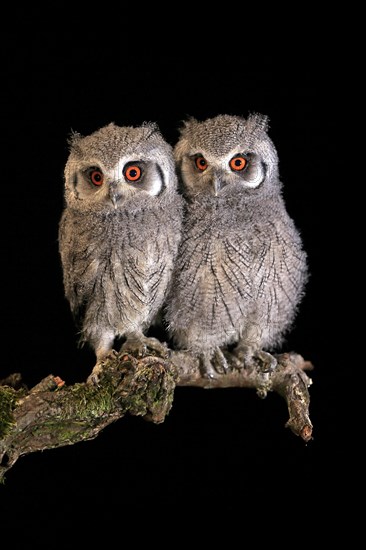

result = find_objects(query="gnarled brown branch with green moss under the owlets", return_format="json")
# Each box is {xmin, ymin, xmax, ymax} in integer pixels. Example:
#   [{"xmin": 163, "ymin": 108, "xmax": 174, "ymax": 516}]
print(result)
[{"xmin": 0, "ymin": 350, "xmax": 313, "ymax": 481}]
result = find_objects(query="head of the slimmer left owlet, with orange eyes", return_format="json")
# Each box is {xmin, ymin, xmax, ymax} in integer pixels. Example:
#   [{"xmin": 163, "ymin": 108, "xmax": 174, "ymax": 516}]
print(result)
[{"xmin": 64, "ymin": 122, "xmax": 177, "ymax": 210}]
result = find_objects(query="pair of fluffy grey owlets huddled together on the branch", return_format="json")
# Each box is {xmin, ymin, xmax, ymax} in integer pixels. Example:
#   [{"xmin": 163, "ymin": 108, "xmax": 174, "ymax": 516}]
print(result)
[{"xmin": 59, "ymin": 114, "xmax": 308, "ymax": 380}]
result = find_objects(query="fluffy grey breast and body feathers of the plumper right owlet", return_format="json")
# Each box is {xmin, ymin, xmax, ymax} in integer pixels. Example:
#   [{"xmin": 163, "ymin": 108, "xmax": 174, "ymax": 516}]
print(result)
[{"xmin": 168, "ymin": 196, "xmax": 303, "ymax": 352}]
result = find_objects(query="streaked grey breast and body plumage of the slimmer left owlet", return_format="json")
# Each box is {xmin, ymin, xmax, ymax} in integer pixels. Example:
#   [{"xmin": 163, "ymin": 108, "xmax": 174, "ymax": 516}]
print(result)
[{"xmin": 62, "ymin": 202, "xmax": 179, "ymax": 340}]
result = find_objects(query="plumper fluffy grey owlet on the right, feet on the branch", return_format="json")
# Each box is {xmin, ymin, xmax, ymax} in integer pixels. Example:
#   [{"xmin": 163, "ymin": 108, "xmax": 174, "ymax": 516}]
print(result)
[{"xmin": 165, "ymin": 114, "xmax": 308, "ymax": 377}]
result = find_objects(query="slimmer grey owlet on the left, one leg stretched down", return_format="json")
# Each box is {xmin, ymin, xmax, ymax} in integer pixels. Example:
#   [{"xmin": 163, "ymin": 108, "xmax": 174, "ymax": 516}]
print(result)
[{"xmin": 59, "ymin": 122, "xmax": 182, "ymax": 382}]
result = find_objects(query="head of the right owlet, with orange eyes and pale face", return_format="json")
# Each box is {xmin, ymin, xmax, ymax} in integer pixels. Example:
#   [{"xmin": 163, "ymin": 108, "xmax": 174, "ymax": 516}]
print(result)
[{"xmin": 174, "ymin": 114, "xmax": 280, "ymax": 203}]
